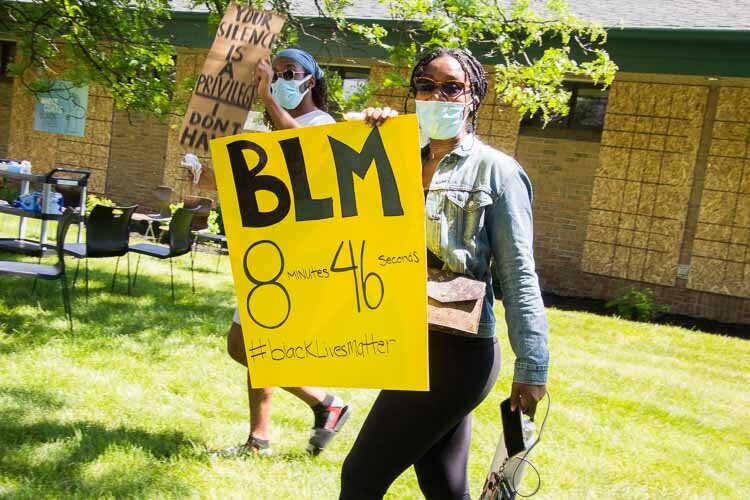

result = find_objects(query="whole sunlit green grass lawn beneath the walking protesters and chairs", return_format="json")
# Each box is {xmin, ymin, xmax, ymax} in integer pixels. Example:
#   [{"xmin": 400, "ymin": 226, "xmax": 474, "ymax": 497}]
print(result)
[{"xmin": 0, "ymin": 215, "xmax": 750, "ymax": 499}]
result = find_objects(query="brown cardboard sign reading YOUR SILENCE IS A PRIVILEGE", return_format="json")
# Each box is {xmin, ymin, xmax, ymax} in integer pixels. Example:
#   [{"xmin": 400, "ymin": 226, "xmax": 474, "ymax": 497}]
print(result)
[{"xmin": 180, "ymin": 2, "xmax": 284, "ymax": 154}]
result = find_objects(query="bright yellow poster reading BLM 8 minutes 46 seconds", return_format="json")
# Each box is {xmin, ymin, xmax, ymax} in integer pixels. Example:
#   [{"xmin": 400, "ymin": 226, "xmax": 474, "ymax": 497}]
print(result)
[{"xmin": 211, "ymin": 115, "xmax": 428, "ymax": 390}]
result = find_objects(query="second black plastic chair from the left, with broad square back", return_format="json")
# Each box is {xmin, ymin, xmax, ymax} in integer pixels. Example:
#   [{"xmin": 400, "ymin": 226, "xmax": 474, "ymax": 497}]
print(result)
[{"xmin": 64, "ymin": 205, "xmax": 138, "ymax": 300}]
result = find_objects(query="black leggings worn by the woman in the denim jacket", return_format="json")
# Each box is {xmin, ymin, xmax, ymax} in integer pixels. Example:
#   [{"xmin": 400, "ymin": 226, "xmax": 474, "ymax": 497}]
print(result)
[{"xmin": 339, "ymin": 332, "xmax": 500, "ymax": 500}]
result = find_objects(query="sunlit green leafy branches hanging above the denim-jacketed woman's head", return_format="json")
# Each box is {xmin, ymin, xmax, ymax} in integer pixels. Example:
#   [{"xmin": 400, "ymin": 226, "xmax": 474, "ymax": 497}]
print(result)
[{"xmin": 347, "ymin": 0, "xmax": 617, "ymax": 122}]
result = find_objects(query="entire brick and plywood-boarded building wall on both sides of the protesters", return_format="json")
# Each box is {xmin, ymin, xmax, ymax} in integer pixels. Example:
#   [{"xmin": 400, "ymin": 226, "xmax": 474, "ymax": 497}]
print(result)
[{"xmin": 0, "ymin": 49, "xmax": 750, "ymax": 324}]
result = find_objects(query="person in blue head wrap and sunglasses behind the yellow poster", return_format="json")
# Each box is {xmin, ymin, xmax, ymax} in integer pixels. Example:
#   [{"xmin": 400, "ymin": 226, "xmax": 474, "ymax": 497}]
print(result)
[{"xmin": 221, "ymin": 49, "xmax": 351, "ymax": 456}]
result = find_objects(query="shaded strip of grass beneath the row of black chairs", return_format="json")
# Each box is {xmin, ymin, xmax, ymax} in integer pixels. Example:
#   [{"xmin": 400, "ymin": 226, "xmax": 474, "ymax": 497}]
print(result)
[{"xmin": 0, "ymin": 254, "xmax": 234, "ymax": 353}]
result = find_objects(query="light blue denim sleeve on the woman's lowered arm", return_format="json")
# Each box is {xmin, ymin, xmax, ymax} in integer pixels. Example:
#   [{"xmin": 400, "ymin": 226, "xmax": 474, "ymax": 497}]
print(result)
[{"xmin": 487, "ymin": 167, "xmax": 549, "ymax": 384}]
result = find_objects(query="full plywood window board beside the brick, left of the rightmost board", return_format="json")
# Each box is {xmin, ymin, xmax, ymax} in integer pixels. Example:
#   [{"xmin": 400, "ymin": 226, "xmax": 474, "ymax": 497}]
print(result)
[{"xmin": 582, "ymin": 82, "xmax": 708, "ymax": 286}]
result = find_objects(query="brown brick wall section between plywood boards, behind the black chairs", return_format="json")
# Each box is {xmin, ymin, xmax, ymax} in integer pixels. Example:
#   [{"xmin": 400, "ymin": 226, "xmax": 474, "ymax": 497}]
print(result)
[{"xmin": 106, "ymin": 110, "xmax": 169, "ymax": 211}]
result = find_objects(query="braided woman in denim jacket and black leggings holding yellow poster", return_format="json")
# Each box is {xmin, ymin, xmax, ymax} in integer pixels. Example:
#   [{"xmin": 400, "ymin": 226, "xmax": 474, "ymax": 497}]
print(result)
[{"xmin": 340, "ymin": 49, "xmax": 549, "ymax": 500}]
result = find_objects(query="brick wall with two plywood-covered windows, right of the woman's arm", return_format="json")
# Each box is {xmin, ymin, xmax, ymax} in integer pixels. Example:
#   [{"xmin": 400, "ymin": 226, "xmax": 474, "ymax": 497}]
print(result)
[{"xmin": 516, "ymin": 75, "xmax": 750, "ymax": 324}]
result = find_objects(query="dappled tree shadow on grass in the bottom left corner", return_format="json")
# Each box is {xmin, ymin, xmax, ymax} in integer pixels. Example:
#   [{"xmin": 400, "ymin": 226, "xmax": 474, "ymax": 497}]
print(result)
[{"xmin": 0, "ymin": 387, "xmax": 199, "ymax": 498}]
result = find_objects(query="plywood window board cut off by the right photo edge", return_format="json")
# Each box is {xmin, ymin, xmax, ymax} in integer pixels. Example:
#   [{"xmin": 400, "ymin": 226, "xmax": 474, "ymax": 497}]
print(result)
[{"xmin": 687, "ymin": 87, "xmax": 750, "ymax": 297}]
